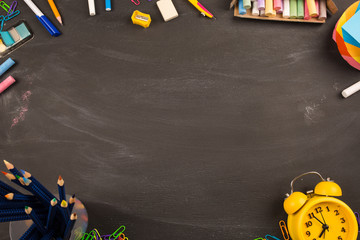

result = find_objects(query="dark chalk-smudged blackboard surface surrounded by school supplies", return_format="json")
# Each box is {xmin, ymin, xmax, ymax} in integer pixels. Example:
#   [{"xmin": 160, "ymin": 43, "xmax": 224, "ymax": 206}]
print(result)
[{"xmin": 0, "ymin": 0, "xmax": 360, "ymax": 240}]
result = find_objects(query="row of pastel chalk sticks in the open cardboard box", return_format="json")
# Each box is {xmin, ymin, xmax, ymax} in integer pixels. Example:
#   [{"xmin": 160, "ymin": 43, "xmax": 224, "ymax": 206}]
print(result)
[{"xmin": 239, "ymin": 0, "xmax": 327, "ymax": 20}]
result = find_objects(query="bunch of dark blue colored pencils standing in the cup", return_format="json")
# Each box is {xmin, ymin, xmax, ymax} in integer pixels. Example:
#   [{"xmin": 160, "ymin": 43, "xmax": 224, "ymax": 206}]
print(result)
[{"xmin": 0, "ymin": 160, "xmax": 77, "ymax": 240}]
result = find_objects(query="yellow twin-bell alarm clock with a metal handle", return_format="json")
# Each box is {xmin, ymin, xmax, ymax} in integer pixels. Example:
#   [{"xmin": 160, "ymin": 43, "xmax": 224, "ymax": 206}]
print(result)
[{"xmin": 284, "ymin": 172, "xmax": 358, "ymax": 240}]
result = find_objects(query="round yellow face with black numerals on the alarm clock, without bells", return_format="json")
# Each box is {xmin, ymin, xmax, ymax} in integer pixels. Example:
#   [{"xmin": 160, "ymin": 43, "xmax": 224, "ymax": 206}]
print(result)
[{"xmin": 299, "ymin": 201, "xmax": 358, "ymax": 240}]
